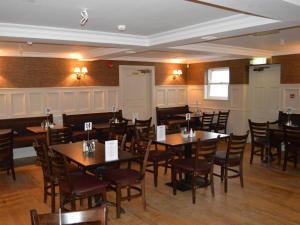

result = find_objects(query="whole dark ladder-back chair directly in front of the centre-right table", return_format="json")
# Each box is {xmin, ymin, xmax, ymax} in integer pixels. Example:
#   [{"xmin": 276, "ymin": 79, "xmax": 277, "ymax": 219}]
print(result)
[{"xmin": 171, "ymin": 137, "xmax": 219, "ymax": 204}]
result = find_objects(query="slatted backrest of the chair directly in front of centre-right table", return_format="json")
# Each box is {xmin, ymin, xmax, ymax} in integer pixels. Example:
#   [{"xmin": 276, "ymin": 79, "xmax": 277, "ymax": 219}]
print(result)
[{"xmin": 194, "ymin": 136, "xmax": 220, "ymax": 168}]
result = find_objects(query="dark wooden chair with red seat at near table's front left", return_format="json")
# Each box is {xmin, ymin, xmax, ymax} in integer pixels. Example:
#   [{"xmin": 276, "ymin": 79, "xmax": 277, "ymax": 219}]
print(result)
[{"xmin": 43, "ymin": 148, "xmax": 109, "ymax": 210}]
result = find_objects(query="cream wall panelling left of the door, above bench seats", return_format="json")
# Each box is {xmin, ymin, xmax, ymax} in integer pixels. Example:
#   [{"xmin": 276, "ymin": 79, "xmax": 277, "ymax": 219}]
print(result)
[{"xmin": 0, "ymin": 86, "xmax": 119, "ymax": 119}]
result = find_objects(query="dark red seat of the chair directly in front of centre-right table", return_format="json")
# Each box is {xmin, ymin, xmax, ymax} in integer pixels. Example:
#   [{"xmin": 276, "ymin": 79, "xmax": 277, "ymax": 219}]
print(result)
[{"xmin": 172, "ymin": 158, "xmax": 212, "ymax": 174}]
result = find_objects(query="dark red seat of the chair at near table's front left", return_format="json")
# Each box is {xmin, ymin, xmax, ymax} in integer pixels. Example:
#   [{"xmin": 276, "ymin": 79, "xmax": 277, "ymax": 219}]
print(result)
[{"xmin": 61, "ymin": 173, "xmax": 109, "ymax": 195}]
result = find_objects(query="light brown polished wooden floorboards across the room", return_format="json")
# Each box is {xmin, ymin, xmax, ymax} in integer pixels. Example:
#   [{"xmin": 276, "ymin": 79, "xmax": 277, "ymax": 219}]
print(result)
[{"xmin": 0, "ymin": 145, "xmax": 300, "ymax": 225}]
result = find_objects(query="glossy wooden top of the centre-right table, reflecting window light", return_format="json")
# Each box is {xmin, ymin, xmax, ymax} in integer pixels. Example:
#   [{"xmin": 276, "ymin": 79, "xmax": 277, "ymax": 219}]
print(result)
[{"xmin": 153, "ymin": 131, "xmax": 229, "ymax": 147}]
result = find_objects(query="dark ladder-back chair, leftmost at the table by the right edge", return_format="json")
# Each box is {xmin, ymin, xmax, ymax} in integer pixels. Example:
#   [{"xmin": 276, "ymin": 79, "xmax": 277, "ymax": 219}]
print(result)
[{"xmin": 248, "ymin": 119, "xmax": 269, "ymax": 164}]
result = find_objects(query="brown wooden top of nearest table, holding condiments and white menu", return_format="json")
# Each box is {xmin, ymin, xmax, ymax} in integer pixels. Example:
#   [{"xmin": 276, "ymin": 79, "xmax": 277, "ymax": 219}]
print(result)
[{"xmin": 50, "ymin": 142, "xmax": 140, "ymax": 168}]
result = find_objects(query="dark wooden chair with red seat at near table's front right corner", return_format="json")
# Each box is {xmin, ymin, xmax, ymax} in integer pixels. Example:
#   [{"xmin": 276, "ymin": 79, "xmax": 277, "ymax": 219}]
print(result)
[{"xmin": 103, "ymin": 140, "xmax": 151, "ymax": 218}]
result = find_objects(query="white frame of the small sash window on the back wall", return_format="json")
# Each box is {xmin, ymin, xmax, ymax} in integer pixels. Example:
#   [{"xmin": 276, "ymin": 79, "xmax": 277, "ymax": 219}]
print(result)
[{"xmin": 204, "ymin": 67, "xmax": 230, "ymax": 101}]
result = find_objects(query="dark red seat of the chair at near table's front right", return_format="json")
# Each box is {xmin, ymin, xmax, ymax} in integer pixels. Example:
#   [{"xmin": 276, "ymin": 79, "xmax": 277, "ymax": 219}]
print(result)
[{"xmin": 103, "ymin": 169, "xmax": 142, "ymax": 186}]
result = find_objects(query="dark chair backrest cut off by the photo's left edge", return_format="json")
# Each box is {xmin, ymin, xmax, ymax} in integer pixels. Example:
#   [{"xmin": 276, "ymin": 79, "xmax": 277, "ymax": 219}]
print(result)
[{"xmin": 0, "ymin": 129, "xmax": 13, "ymax": 163}]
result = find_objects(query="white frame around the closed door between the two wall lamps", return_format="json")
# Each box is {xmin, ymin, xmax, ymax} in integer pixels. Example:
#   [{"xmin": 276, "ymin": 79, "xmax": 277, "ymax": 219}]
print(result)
[{"xmin": 119, "ymin": 65, "xmax": 156, "ymax": 124}]
